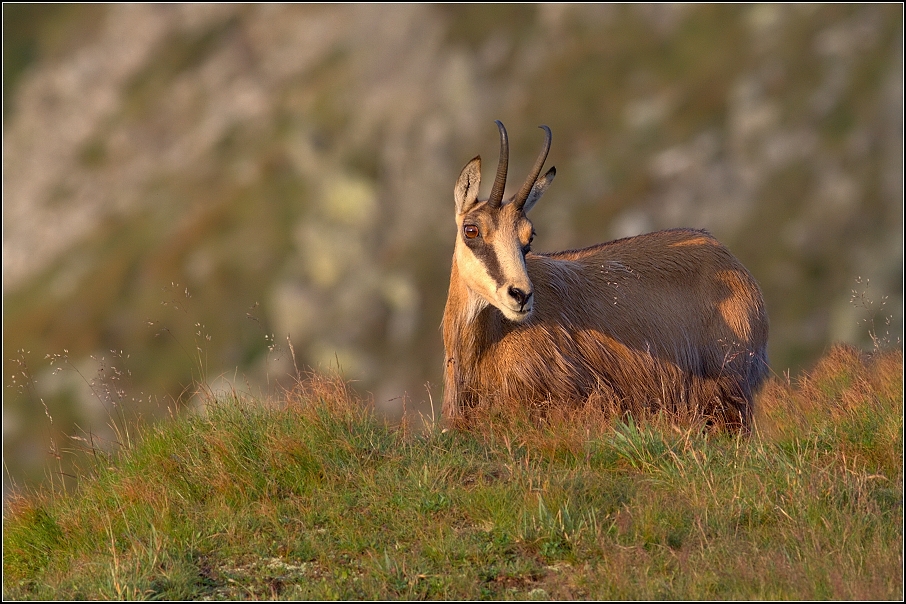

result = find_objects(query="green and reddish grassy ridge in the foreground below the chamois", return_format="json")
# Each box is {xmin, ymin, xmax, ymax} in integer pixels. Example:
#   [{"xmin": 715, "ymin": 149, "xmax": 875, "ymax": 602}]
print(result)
[{"xmin": 3, "ymin": 347, "xmax": 903, "ymax": 600}]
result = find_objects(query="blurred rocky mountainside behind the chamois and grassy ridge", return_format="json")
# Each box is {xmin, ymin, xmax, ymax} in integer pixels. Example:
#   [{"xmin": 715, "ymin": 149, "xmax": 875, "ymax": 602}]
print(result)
[{"xmin": 3, "ymin": 4, "xmax": 903, "ymax": 494}]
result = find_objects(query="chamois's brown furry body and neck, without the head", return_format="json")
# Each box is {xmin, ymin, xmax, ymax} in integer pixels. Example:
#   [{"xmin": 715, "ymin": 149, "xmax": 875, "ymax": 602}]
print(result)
[{"xmin": 443, "ymin": 229, "xmax": 768, "ymax": 426}]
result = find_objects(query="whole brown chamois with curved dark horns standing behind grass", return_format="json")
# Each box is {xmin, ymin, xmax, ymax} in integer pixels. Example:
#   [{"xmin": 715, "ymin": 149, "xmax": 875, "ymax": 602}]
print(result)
[{"xmin": 443, "ymin": 121, "xmax": 768, "ymax": 430}]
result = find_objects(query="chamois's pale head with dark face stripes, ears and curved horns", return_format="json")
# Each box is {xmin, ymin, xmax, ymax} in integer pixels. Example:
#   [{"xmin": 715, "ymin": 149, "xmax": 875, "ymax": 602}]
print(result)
[{"xmin": 453, "ymin": 121, "xmax": 557, "ymax": 323}]
